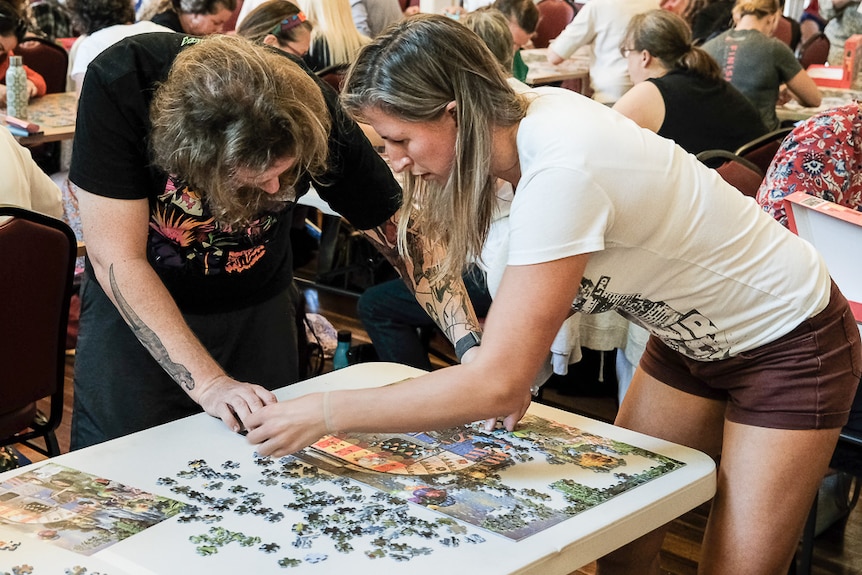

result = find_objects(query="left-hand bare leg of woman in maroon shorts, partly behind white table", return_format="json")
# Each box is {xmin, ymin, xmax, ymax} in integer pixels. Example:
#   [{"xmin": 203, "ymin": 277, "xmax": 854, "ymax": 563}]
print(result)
[{"xmin": 596, "ymin": 369, "xmax": 728, "ymax": 575}]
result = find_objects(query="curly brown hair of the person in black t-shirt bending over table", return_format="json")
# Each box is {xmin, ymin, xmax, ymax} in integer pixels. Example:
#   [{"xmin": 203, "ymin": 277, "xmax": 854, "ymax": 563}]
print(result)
[{"xmin": 150, "ymin": 34, "xmax": 332, "ymax": 227}]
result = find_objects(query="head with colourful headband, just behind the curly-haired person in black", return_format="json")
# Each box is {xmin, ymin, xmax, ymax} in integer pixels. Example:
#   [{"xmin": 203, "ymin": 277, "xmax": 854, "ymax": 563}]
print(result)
[{"xmin": 236, "ymin": 0, "xmax": 311, "ymax": 58}]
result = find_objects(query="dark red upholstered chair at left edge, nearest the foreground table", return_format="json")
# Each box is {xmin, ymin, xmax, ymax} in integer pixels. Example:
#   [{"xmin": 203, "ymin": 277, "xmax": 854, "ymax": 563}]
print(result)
[{"xmin": 0, "ymin": 206, "xmax": 77, "ymax": 457}]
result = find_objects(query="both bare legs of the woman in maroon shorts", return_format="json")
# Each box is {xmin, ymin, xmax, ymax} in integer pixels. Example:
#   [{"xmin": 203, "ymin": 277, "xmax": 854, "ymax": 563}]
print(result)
[{"xmin": 596, "ymin": 370, "xmax": 840, "ymax": 575}]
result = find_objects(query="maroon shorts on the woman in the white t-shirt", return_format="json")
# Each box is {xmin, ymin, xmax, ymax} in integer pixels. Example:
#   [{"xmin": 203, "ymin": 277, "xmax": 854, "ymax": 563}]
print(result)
[{"xmin": 640, "ymin": 282, "xmax": 862, "ymax": 429}]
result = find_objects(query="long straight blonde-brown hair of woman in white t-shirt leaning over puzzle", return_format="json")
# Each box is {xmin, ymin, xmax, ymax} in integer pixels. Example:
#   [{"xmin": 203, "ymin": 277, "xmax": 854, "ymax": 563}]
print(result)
[{"xmin": 341, "ymin": 15, "xmax": 527, "ymax": 276}]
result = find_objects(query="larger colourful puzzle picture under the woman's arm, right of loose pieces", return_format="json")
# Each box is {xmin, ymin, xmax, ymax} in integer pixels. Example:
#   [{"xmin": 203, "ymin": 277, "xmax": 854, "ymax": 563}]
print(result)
[{"xmin": 297, "ymin": 415, "xmax": 684, "ymax": 540}]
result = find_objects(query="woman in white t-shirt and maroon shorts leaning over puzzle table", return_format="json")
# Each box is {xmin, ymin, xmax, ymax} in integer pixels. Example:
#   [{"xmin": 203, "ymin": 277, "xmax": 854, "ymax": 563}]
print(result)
[{"xmin": 247, "ymin": 15, "xmax": 862, "ymax": 575}]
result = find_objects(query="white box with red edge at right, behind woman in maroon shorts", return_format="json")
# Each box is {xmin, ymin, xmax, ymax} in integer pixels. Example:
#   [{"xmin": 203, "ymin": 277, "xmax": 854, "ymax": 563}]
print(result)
[{"xmin": 784, "ymin": 192, "xmax": 862, "ymax": 322}]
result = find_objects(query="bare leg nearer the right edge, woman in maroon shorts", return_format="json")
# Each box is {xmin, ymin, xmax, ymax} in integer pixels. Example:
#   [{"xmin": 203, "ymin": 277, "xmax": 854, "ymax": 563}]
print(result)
[{"xmin": 698, "ymin": 422, "xmax": 839, "ymax": 575}]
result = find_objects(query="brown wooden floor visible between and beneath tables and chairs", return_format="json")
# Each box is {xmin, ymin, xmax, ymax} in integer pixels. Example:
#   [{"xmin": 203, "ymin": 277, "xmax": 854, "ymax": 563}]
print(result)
[{"xmin": 22, "ymin": 290, "xmax": 862, "ymax": 575}]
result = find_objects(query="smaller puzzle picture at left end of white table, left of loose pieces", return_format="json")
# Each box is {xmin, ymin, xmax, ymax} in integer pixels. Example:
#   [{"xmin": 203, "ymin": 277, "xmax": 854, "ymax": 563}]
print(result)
[{"xmin": 0, "ymin": 463, "xmax": 186, "ymax": 555}]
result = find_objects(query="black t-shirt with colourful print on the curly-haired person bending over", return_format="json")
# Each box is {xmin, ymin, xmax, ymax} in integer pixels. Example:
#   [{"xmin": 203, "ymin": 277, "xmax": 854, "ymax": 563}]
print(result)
[{"xmin": 69, "ymin": 33, "xmax": 401, "ymax": 313}]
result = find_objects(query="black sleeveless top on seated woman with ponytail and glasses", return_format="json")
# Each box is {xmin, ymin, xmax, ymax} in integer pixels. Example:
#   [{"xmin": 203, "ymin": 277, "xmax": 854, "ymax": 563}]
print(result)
[{"xmin": 647, "ymin": 71, "xmax": 767, "ymax": 158}]
